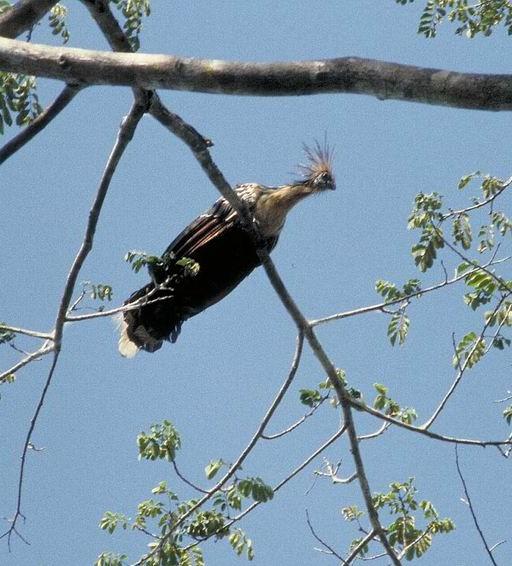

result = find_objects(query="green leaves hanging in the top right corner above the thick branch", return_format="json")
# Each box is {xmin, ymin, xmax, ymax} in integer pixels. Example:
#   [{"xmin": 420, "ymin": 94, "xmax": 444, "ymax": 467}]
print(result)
[{"xmin": 402, "ymin": 0, "xmax": 512, "ymax": 38}]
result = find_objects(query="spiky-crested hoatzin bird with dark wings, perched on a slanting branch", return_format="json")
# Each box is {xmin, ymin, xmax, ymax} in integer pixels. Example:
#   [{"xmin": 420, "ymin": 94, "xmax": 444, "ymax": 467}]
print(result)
[{"xmin": 119, "ymin": 141, "xmax": 336, "ymax": 358}]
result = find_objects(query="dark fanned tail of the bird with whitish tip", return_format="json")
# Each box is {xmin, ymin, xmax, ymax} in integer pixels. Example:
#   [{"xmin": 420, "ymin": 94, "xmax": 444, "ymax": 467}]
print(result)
[{"xmin": 119, "ymin": 283, "xmax": 183, "ymax": 358}]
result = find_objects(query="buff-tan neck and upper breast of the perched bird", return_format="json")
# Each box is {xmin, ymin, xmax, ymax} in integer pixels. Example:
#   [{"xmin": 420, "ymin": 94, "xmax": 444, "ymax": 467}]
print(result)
[{"xmin": 255, "ymin": 185, "xmax": 313, "ymax": 238}]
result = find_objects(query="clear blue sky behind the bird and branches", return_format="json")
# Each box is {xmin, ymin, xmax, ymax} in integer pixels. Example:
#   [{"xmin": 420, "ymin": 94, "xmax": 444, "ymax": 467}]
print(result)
[{"xmin": 0, "ymin": 0, "xmax": 512, "ymax": 566}]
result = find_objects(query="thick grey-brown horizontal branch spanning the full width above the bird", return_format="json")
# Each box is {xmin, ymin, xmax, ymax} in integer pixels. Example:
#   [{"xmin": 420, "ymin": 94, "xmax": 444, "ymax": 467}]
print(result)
[{"xmin": 0, "ymin": 38, "xmax": 512, "ymax": 110}]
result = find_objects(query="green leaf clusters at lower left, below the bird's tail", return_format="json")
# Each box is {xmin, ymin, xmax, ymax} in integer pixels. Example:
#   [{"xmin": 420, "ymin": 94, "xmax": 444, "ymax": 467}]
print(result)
[{"xmin": 96, "ymin": 420, "xmax": 274, "ymax": 566}]
